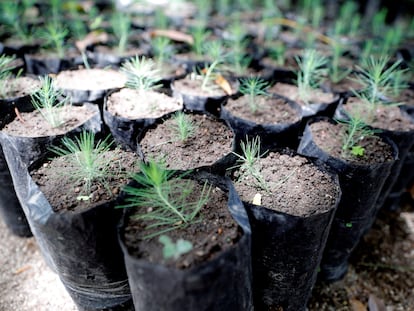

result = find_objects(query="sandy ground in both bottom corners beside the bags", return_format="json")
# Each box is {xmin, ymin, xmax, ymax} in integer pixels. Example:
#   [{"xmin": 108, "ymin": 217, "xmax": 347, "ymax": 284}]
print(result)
[{"xmin": 0, "ymin": 193, "xmax": 414, "ymax": 311}]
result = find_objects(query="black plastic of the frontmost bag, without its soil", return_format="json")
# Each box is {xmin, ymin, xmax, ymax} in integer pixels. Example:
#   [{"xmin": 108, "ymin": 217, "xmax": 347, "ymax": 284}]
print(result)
[{"xmin": 119, "ymin": 174, "xmax": 253, "ymax": 311}]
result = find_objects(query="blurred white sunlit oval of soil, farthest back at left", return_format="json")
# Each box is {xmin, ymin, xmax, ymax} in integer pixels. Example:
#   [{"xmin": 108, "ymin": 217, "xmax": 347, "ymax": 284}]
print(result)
[{"xmin": 56, "ymin": 68, "xmax": 126, "ymax": 90}]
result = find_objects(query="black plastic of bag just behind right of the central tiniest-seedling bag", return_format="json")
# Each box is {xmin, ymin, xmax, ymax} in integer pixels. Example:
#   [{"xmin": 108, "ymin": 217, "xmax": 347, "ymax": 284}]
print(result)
[{"xmin": 220, "ymin": 96, "xmax": 301, "ymax": 150}]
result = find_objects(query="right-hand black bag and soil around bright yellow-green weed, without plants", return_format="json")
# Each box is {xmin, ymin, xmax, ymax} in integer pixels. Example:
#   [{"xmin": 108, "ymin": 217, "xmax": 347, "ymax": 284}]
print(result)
[{"xmin": 298, "ymin": 119, "xmax": 398, "ymax": 281}]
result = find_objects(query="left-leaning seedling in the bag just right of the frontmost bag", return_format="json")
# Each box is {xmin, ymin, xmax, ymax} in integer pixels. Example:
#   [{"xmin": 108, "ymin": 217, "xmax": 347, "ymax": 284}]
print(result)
[{"xmin": 233, "ymin": 136, "xmax": 270, "ymax": 192}]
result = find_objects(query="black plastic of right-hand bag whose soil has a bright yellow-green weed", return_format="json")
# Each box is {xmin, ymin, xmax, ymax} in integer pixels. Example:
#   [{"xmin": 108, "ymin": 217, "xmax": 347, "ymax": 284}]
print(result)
[{"xmin": 298, "ymin": 120, "xmax": 398, "ymax": 281}]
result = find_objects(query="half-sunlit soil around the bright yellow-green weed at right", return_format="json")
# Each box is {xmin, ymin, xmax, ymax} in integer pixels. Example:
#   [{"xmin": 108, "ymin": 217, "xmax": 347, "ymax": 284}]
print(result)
[{"xmin": 310, "ymin": 121, "xmax": 393, "ymax": 165}]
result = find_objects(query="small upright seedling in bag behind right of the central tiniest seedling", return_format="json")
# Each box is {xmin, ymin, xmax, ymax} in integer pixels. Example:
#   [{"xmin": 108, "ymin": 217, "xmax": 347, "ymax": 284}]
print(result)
[{"xmin": 240, "ymin": 77, "xmax": 269, "ymax": 114}]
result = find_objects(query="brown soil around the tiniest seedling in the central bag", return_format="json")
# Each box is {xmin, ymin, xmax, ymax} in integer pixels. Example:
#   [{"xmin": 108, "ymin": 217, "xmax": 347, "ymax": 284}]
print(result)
[{"xmin": 140, "ymin": 114, "xmax": 234, "ymax": 170}]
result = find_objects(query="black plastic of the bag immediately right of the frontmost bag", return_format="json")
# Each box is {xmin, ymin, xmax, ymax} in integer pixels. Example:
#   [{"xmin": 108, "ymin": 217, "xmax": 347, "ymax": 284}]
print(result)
[{"xmin": 244, "ymin": 151, "xmax": 340, "ymax": 311}]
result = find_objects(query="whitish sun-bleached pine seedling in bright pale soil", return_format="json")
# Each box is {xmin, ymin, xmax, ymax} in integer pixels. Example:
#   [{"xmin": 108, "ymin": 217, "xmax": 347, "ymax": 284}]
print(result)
[{"xmin": 121, "ymin": 56, "xmax": 161, "ymax": 91}]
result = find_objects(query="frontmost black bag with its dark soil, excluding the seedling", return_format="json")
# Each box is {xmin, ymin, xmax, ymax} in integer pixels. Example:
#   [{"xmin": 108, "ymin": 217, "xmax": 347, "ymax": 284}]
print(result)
[{"xmin": 119, "ymin": 173, "xmax": 253, "ymax": 311}]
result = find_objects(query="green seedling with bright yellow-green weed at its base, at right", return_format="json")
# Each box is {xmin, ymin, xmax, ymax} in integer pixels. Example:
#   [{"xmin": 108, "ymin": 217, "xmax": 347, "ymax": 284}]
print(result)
[{"xmin": 336, "ymin": 116, "xmax": 378, "ymax": 158}]
